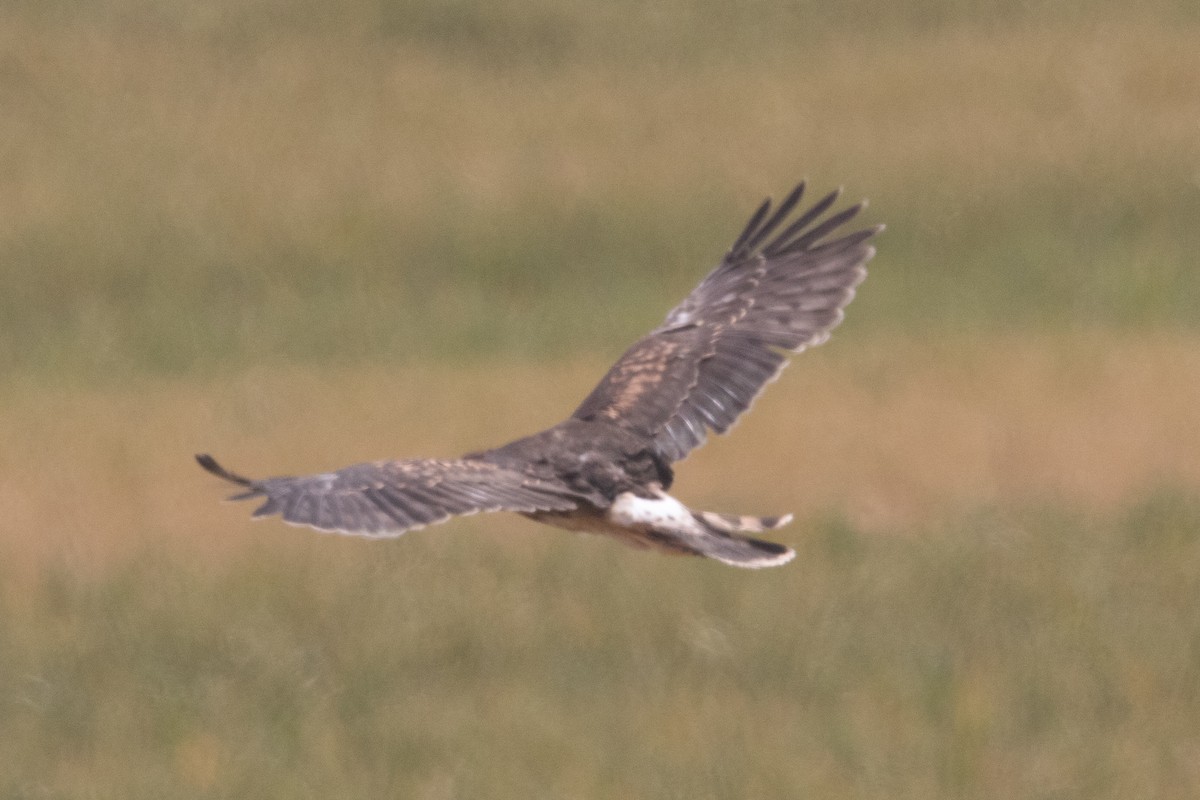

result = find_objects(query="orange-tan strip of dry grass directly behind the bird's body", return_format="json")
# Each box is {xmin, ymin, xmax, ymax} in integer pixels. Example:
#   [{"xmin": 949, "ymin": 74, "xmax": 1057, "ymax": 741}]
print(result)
[{"xmin": 0, "ymin": 332, "xmax": 1200, "ymax": 575}]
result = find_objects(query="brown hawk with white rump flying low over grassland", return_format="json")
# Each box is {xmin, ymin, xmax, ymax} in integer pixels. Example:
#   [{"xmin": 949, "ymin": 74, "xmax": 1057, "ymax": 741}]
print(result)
[{"xmin": 196, "ymin": 182, "xmax": 883, "ymax": 567}]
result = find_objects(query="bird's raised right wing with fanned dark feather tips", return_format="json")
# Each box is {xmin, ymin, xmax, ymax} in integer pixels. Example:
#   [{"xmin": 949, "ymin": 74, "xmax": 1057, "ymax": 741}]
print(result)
[{"xmin": 574, "ymin": 184, "xmax": 883, "ymax": 461}]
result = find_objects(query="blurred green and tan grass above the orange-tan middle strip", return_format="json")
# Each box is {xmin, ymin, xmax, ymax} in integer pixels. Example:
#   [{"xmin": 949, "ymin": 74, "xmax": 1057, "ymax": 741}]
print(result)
[{"xmin": 0, "ymin": 0, "xmax": 1200, "ymax": 380}]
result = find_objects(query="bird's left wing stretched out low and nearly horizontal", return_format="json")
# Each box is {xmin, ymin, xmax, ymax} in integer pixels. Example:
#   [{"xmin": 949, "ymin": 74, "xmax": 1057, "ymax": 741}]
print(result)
[{"xmin": 196, "ymin": 455, "xmax": 577, "ymax": 537}]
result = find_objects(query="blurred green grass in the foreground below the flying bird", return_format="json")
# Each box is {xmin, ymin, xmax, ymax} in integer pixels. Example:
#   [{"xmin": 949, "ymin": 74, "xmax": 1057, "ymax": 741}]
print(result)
[{"xmin": 7, "ymin": 493, "xmax": 1200, "ymax": 800}]
